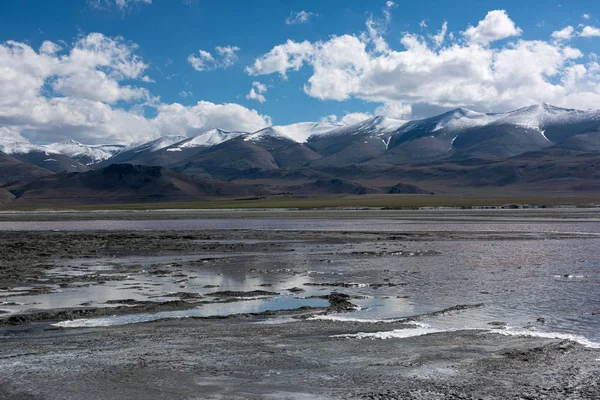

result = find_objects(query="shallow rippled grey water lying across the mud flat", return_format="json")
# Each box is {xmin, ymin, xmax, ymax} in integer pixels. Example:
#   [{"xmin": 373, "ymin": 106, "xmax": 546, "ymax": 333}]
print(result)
[{"xmin": 0, "ymin": 218, "xmax": 600, "ymax": 342}]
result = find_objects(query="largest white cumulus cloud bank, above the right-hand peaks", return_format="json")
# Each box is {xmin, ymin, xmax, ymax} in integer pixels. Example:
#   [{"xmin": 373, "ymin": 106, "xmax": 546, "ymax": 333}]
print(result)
[{"xmin": 246, "ymin": 11, "xmax": 600, "ymax": 115}]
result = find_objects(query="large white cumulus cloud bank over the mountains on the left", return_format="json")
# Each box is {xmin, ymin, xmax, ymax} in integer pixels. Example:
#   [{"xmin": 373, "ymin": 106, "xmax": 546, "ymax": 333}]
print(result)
[{"xmin": 0, "ymin": 33, "xmax": 271, "ymax": 144}]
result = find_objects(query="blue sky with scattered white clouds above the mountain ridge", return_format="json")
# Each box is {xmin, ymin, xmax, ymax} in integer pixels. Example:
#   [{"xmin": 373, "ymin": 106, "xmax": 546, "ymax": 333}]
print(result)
[{"xmin": 0, "ymin": 0, "xmax": 600, "ymax": 144}]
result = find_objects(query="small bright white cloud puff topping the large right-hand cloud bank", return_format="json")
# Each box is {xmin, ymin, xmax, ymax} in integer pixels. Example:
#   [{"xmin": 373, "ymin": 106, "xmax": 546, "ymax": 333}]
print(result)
[{"xmin": 463, "ymin": 10, "xmax": 523, "ymax": 45}]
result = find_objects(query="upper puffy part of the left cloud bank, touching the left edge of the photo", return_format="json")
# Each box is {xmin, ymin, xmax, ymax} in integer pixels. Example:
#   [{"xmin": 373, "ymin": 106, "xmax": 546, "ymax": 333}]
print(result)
[{"xmin": 0, "ymin": 33, "xmax": 148, "ymax": 107}]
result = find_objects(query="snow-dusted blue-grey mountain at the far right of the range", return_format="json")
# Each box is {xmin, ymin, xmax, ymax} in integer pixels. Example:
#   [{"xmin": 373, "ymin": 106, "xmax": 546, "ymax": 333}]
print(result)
[{"xmin": 369, "ymin": 104, "xmax": 600, "ymax": 165}]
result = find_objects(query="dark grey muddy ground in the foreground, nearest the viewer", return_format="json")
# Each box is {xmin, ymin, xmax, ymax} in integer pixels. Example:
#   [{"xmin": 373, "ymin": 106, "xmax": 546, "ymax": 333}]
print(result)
[{"xmin": 0, "ymin": 316, "xmax": 600, "ymax": 399}]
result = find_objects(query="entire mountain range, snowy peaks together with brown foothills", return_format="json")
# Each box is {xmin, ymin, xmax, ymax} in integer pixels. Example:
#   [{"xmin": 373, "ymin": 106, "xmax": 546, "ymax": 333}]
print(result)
[{"xmin": 0, "ymin": 104, "xmax": 600, "ymax": 202}]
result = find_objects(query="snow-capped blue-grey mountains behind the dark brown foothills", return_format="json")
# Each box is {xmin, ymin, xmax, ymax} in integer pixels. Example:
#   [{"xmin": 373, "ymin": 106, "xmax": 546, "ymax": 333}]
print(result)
[{"xmin": 0, "ymin": 104, "xmax": 600, "ymax": 179}]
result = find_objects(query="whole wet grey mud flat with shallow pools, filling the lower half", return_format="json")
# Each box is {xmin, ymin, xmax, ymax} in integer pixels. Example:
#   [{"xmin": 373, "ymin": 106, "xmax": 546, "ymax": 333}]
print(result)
[{"xmin": 0, "ymin": 212, "xmax": 600, "ymax": 399}]
